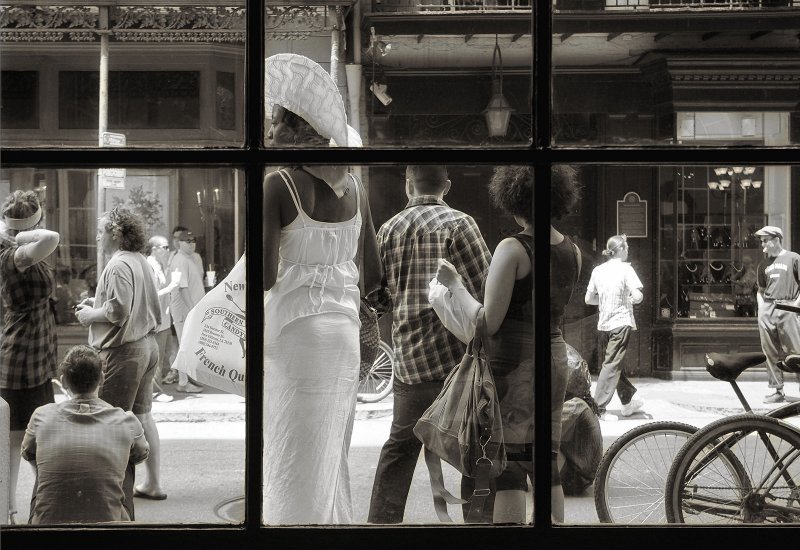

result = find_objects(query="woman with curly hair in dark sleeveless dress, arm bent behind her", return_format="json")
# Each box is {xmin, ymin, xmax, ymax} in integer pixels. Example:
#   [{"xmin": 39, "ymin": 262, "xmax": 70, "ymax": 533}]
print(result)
[{"xmin": 436, "ymin": 166, "xmax": 580, "ymax": 523}]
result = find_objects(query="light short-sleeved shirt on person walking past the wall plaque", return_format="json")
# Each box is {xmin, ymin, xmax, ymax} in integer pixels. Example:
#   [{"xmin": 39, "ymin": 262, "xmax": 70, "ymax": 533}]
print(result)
[{"xmin": 586, "ymin": 258, "xmax": 642, "ymax": 331}]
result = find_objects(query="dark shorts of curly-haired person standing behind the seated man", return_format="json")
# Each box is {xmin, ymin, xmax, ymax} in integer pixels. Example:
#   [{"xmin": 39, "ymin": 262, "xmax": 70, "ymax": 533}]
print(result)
[{"xmin": 100, "ymin": 334, "xmax": 158, "ymax": 414}]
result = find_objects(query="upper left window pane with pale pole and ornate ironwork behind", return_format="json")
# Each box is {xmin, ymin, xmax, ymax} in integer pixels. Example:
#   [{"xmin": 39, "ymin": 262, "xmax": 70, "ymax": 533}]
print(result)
[{"xmin": 0, "ymin": 2, "xmax": 245, "ymax": 147}]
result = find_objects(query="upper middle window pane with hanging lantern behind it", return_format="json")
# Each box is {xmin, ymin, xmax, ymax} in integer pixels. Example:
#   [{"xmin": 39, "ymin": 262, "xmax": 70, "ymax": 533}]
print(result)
[{"xmin": 265, "ymin": 1, "xmax": 533, "ymax": 147}]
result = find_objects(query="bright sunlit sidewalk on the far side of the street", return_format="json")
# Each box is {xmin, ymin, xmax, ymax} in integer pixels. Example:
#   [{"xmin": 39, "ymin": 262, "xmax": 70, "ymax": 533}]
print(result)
[{"xmin": 147, "ymin": 378, "xmax": 800, "ymax": 426}]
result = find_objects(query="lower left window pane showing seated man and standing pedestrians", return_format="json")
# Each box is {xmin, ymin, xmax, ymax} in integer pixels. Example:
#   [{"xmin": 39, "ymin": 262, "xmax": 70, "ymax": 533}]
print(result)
[{"xmin": 0, "ymin": 167, "xmax": 246, "ymax": 524}]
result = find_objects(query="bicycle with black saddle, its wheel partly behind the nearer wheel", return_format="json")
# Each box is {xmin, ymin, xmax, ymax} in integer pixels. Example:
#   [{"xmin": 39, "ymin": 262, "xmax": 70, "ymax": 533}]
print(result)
[{"xmin": 594, "ymin": 340, "xmax": 800, "ymax": 524}]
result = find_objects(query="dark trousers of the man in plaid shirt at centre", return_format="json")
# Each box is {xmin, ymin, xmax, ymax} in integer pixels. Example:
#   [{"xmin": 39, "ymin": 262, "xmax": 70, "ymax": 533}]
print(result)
[{"xmin": 367, "ymin": 378, "xmax": 454, "ymax": 523}]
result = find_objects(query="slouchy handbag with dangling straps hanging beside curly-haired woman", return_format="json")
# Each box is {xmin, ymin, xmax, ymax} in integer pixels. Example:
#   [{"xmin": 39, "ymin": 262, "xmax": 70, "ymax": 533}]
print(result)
[{"xmin": 414, "ymin": 308, "xmax": 506, "ymax": 523}]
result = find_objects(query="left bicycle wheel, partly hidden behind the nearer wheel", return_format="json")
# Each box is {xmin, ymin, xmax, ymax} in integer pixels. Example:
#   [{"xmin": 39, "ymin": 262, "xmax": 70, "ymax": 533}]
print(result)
[{"xmin": 594, "ymin": 422, "xmax": 697, "ymax": 524}]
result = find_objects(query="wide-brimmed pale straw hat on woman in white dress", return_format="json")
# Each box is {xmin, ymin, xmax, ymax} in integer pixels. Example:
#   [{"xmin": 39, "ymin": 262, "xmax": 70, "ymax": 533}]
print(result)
[{"xmin": 265, "ymin": 53, "xmax": 362, "ymax": 147}]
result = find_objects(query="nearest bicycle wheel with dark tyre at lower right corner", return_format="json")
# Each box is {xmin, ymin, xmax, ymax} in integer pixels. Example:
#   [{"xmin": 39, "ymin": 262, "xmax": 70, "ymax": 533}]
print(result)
[{"xmin": 666, "ymin": 413, "xmax": 800, "ymax": 524}]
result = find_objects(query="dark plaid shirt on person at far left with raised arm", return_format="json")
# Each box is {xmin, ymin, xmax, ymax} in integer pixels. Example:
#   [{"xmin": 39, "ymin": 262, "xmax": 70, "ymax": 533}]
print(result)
[{"xmin": 0, "ymin": 235, "xmax": 57, "ymax": 390}]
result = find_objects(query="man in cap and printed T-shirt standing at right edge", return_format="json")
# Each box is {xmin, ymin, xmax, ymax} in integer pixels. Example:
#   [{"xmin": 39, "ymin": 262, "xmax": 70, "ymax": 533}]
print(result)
[{"xmin": 755, "ymin": 225, "xmax": 800, "ymax": 403}]
